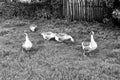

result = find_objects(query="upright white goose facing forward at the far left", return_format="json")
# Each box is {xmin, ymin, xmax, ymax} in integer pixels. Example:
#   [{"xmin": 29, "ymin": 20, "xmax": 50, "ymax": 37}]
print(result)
[{"xmin": 22, "ymin": 33, "xmax": 33, "ymax": 51}]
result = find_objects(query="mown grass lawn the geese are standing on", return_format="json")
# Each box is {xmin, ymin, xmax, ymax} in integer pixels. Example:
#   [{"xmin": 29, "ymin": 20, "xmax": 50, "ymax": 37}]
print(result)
[{"xmin": 0, "ymin": 19, "xmax": 120, "ymax": 80}]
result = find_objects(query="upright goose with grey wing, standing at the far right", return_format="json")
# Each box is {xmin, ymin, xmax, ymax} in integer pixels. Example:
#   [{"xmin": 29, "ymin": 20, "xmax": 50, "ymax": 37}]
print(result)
[{"xmin": 82, "ymin": 31, "xmax": 97, "ymax": 55}]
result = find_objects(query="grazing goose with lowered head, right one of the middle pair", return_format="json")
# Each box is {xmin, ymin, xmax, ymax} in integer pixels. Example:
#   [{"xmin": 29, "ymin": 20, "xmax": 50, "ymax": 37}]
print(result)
[{"xmin": 55, "ymin": 33, "xmax": 74, "ymax": 42}]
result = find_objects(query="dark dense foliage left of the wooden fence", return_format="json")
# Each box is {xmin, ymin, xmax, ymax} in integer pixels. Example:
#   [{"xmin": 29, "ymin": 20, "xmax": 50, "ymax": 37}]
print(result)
[{"xmin": 0, "ymin": 0, "xmax": 61, "ymax": 19}]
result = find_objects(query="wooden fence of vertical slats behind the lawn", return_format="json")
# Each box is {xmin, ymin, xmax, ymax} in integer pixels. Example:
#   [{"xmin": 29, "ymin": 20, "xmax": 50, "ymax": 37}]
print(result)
[{"xmin": 62, "ymin": 0, "xmax": 105, "ymax": 21}]
